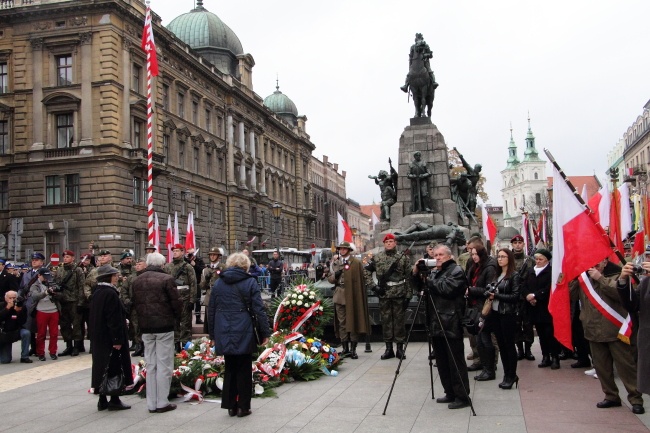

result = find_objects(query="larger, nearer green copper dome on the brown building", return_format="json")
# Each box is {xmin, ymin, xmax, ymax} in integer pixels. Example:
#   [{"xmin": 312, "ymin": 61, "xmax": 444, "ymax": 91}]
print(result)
[{"xmin": 167, "ymin": 0, "xmax": 244, "ymax": 75}]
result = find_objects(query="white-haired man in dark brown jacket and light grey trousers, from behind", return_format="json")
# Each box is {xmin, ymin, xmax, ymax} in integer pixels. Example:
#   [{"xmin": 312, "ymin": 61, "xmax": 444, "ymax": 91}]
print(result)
[{"xmin": 131, "ymin": 253, "xmax": 183, "ymax": 413}]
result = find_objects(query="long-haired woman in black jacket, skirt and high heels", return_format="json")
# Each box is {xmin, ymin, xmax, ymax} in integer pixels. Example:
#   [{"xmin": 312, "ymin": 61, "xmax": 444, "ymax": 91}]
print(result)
[{"xmin": 481, "ymin": 248, "xmax": 520, "ymax": 389}]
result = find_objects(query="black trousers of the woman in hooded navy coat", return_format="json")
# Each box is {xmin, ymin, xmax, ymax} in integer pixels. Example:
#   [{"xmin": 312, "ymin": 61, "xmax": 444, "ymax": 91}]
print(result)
[{"xmin": 221, "ymin": 353, "xmax": 253, "ymax": 410}]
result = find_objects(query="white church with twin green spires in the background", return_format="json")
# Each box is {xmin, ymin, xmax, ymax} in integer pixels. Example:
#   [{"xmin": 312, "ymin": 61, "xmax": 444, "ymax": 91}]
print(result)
[{"xmin": 501, "ymin": 119, "xmax": 548, "ymax": 230}]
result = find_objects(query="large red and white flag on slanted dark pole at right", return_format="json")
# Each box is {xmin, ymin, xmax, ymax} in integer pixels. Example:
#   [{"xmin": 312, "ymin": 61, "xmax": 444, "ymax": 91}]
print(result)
[{"xmin": 548, "ymin": 166, "xmax": 612, "ymax": 348}]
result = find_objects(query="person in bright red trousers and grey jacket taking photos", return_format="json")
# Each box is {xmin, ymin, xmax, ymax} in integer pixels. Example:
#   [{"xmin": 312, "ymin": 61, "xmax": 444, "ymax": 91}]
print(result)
[{"xmin": 29, "ymin": 268, "xmax": 61, "ymax": 361}]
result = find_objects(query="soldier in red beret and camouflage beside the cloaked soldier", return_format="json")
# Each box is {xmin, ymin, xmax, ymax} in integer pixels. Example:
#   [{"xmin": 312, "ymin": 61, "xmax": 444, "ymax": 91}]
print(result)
[{"xmin": 367, "ymin": 233, "xmax": 412, "ymax": 359}]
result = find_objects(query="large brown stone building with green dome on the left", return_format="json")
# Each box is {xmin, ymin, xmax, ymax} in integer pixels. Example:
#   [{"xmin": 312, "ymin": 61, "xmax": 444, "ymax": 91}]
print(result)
[{"xmin": 0, "ymin": 0, "xmax": 316, "ymax": 259}]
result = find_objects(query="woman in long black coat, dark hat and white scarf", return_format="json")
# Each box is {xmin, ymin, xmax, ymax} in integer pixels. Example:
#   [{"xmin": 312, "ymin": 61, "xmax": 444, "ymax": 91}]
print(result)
[{"xmin": 522, "ymin": 248, "xmax": 560, "ymax": 370}]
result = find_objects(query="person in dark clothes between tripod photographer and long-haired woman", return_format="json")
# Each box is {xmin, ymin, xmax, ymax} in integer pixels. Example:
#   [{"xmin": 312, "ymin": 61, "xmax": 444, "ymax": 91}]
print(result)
[{"xmin": 467, "ymin": 245, "xmax": 497, "ymax": 381}]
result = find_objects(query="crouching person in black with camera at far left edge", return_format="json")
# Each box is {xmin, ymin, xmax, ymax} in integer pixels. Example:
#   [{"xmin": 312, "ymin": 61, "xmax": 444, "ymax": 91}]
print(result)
[{"xmin": 0, "ymin": 290, "xmax": 33, "ymax": 364}]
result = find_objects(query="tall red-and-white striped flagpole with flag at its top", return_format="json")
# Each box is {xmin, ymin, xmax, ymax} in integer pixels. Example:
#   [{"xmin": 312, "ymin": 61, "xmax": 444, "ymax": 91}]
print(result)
[{"xmin": 142, "ymin": 1, "xmax": 158, "ymax": 244}]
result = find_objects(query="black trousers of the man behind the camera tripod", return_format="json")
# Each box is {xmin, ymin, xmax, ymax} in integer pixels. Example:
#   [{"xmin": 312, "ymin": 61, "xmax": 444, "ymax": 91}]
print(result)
[{"xmin": 433, "ymin": 337, "xmax": 469, "ymax": 400}]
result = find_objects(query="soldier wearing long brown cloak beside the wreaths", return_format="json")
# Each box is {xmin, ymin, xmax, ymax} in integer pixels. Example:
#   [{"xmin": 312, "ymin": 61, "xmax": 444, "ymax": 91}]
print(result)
[{"xmin": 328, "ymin": 242, "xmax": 370, "ymax": 359}]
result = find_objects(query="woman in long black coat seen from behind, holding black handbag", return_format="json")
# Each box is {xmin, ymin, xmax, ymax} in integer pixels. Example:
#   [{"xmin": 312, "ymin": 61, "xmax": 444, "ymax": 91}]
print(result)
[{"xmin": 89, "ymin": 265, "xmax": 133, "ymax": 410}]
